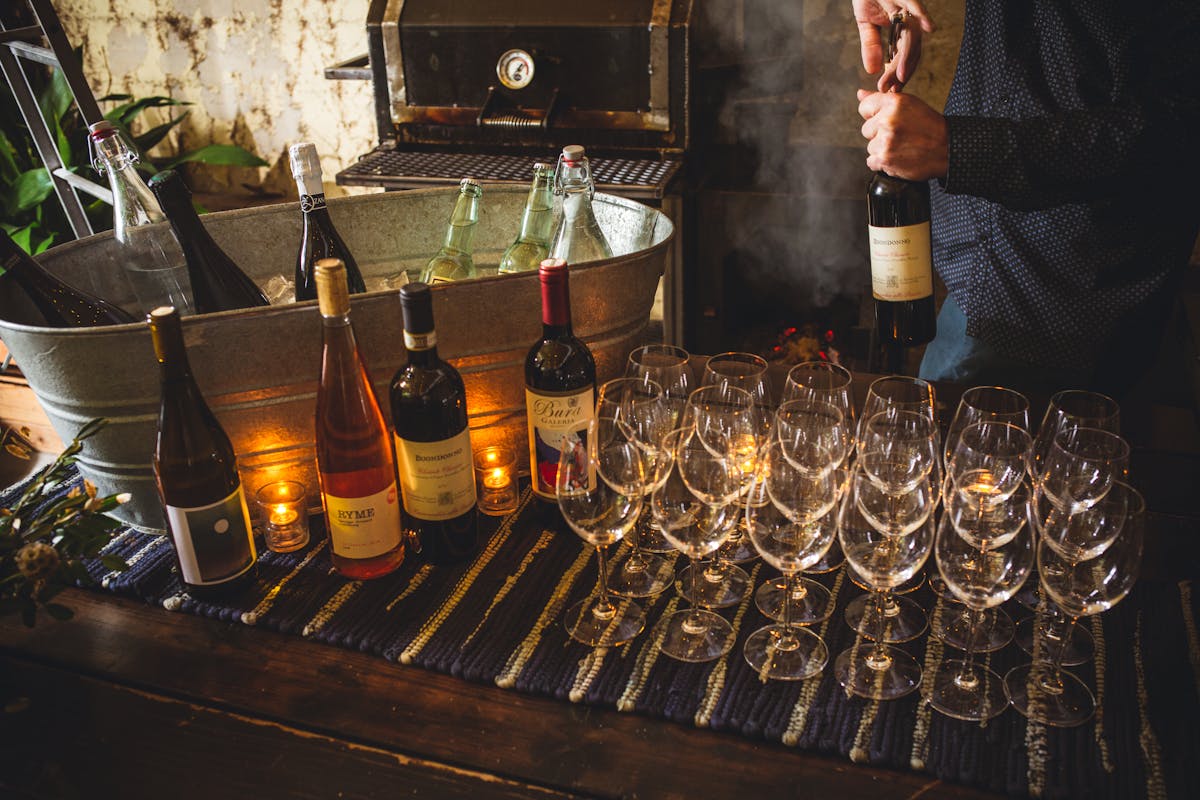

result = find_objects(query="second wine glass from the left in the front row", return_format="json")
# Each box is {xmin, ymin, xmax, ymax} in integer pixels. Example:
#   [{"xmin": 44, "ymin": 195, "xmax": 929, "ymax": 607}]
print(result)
[{"xmin": 650, "ymin": 426, "xmax": 742, "ymax": 662}]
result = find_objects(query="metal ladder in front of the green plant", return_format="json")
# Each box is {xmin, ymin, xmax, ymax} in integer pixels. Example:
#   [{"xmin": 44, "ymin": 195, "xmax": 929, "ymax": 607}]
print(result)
[{"xmin": 0, "ymin": 0, "xmax": 113, "ymax": 239}]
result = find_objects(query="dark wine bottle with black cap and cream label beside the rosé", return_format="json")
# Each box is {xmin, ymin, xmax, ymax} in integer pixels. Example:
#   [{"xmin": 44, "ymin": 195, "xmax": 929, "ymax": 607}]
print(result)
[{"xmin": 390, "ymin": 283, "xmax": 479, "ymax": 564}]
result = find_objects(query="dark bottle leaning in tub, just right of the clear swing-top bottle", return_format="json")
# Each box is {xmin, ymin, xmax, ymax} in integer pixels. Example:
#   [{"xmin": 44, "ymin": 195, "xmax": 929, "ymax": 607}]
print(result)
[{"xmin": 150, "ymin": 169, "xmax": 270, "ymax": 314}]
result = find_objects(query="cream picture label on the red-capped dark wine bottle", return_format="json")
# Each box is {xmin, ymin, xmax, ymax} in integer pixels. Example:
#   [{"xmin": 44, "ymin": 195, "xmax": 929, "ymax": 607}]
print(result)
[{"xmin": 526, "ymin": 384, "xmax": 595, "ymax": 500}]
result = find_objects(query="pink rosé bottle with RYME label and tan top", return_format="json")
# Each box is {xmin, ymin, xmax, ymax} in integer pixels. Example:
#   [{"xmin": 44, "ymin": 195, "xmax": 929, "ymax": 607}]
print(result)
[{"xmin": 316, "ymin": 258, "xmax": 404, "ymax": 578}]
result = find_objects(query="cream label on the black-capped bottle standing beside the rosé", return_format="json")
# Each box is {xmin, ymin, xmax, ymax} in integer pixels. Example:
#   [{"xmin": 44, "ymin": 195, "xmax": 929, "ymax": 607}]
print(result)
[{"xmin": 396, "ymin": 428, "xmax": 475, "ymax": 521}]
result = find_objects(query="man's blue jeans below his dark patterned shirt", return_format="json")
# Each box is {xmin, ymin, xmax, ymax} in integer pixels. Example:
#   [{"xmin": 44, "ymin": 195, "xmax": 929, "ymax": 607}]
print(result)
[{"xmin": 919, "ymin": 295, "xmax": 1091, "ymax": 395}]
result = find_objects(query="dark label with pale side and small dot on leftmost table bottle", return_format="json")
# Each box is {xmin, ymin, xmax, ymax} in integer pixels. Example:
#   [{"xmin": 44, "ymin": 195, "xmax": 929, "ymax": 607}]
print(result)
[{"xmin": 166, "ymin": 483, "xmax": 256, "ymax": 587}]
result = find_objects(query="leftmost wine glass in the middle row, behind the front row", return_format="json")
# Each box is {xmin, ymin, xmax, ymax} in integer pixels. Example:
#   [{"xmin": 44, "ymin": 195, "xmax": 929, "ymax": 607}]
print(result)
[{"xmin": 596, "ymin": 378, "xmax": 674, "ymax": 597}]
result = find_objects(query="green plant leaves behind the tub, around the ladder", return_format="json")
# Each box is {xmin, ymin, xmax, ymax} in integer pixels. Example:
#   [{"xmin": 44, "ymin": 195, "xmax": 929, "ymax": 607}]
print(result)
[{"xmin": 0, "ymin": 56, "xmax": 268, "ymax": 254}]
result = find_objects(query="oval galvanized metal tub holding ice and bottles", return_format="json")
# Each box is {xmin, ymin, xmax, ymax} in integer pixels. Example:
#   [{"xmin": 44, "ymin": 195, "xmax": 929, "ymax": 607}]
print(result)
[{"xmin": 0, "ymin": 187, "xmax": 673, "ymax": 530}]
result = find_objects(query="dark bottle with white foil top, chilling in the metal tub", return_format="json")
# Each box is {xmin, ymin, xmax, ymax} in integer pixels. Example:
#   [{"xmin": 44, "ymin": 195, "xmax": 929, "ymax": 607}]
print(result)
[{"xmin": 288, "ymin": 142, "xmax": 367, "ymax": 302}]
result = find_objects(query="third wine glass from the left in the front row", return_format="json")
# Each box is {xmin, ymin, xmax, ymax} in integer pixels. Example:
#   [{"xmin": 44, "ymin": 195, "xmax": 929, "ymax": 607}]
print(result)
[{"xmin": 743, "ymin": 441, "xmax": 838, "ymax": 680}]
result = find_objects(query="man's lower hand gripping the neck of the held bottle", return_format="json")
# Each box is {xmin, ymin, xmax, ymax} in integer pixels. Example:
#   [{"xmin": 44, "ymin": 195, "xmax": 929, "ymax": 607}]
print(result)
[{"xmin": 858, "ymin": 89, "xmax": 950, "ymax": 181}]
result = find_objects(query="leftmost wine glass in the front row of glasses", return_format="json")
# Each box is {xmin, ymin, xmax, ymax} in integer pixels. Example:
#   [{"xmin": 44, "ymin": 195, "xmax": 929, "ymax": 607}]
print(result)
[{"xmin": 554, "ymin": 417, "xmax": 646, "ymax": 646}]
